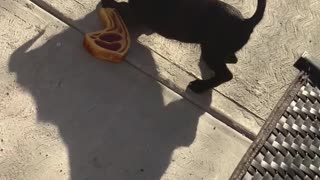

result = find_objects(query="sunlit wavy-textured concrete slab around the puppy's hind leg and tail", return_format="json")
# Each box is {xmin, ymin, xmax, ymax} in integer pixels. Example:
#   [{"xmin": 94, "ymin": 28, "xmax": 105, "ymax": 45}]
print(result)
[{"xmin": 136, "ymin": 0, "xmax": 320, "ymax": 119}]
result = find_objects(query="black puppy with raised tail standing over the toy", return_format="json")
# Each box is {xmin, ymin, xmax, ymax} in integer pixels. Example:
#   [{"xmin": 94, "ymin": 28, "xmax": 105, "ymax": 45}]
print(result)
[{"xmin": 102, "ymin": 0, "xmax": 266, "ymax": 93}]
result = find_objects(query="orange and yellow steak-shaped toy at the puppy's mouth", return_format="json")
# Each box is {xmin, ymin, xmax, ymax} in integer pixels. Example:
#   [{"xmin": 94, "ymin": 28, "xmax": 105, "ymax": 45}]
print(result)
[{"xmin": 84, "ymin": 8, "xmax": 130, "ymax": 63}]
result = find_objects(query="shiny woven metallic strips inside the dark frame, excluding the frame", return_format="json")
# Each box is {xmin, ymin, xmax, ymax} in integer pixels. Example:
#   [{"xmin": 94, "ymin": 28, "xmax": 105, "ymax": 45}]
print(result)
[{"xmin": 243, "ymin": 82, "xmax": 320, "ymax": 180}]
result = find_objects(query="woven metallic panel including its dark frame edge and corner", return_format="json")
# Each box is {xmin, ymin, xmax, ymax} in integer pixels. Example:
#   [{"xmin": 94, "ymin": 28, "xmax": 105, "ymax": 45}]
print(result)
[{"xmin": 231, "ymin": 51, "xmax": 320, "ymax": 180}]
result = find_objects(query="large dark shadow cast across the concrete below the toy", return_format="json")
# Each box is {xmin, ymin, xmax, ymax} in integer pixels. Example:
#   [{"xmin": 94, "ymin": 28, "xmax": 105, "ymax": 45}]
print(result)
[{"xmin": 9, "ymin": 3, "xmax": 211, "ymax": 180}]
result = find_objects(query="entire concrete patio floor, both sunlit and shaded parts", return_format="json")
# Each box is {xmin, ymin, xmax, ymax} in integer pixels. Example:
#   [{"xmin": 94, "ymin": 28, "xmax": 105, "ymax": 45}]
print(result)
[{"xmin": 0, "ymin": 0, "xmax": 320, "ymax": 180}]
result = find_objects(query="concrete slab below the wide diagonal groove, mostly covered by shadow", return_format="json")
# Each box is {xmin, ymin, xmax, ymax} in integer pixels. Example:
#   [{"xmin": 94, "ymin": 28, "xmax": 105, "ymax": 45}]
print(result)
[{"xmin": 0, "ymin": 0, "xmax": 250, "ymax": 180}]
